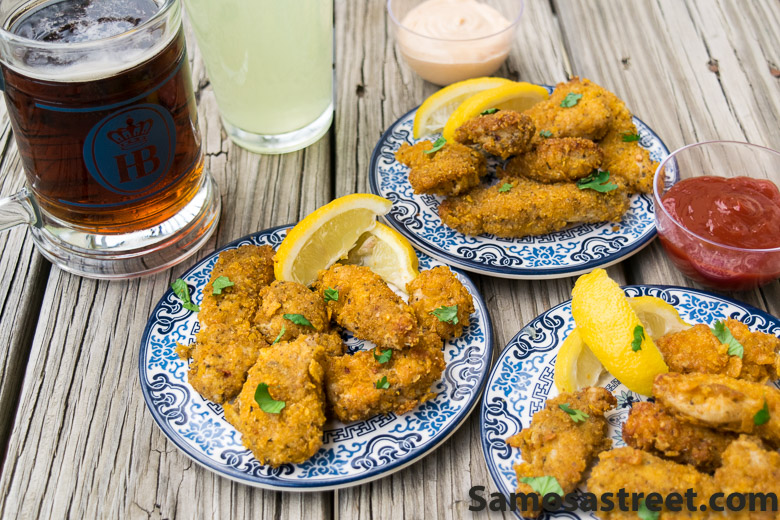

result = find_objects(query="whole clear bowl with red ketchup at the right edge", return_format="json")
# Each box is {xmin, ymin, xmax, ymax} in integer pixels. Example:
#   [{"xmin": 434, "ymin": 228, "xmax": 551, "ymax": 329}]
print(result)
[{"xmin": 654, "ymin": 141, "xmax": 780, "ymax": 291}]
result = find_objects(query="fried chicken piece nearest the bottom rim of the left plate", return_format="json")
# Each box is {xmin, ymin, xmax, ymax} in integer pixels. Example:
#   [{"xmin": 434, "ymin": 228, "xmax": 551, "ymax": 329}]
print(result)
[{"xmin": 225, "ymin": 336, "xmax": 325, "ymax": 466}]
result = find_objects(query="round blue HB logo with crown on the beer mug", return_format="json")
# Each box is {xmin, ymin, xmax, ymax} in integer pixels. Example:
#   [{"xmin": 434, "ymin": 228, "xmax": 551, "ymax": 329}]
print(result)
[{"xmin": 84, "ymin": 104, "xmax": 176, "ymax": 195}]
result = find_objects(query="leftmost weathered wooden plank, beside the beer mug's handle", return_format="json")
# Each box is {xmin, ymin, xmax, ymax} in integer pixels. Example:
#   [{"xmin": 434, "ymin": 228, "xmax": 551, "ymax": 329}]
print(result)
[{"xmin": 0, "ymin": 90, "xmax": 50, "ymax": 467}]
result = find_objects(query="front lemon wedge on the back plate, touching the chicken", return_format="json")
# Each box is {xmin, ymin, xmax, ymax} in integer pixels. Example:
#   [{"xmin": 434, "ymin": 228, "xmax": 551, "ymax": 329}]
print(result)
[{"xmin": 442, "ymin": 81, "xmax": 550, "ymax": 141}]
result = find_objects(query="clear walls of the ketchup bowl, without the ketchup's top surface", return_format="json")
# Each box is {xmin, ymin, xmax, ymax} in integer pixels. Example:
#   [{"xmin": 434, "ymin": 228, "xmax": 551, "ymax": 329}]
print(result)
[{"xmin": 654, "ymin": 141, "xmax": 780, "ymax": 291}]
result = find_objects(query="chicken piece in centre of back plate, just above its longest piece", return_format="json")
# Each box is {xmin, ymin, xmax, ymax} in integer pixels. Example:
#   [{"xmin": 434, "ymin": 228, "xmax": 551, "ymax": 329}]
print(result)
[{"xmin": 497, "ymin": 137, "xmax": 603, "ymax": 183}]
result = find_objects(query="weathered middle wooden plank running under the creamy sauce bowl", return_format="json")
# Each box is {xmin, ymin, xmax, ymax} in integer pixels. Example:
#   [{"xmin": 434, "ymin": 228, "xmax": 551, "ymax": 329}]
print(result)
[{"xmin": 335, "ymin": 1, "xmax": 580, "ymax": 519}]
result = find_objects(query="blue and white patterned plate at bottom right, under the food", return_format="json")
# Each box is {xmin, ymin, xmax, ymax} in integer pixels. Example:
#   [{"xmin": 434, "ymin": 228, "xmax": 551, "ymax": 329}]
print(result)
[{"xmin": 479, "ymin": 285, "xmax": 780, "ymax": 520}]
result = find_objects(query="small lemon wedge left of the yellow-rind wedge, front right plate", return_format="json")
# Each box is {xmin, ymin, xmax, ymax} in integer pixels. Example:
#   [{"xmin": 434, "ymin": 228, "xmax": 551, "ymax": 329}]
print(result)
[{"xmin": 553, "ymin": 328, "xmax": 604, "ymax": 392}]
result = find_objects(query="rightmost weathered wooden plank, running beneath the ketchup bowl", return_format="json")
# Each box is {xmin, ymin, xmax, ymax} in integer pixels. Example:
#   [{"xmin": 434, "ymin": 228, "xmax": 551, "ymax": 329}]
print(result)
[{"xmin": 555, "ymin": 0, "xmax": 780, "ymax": 315}]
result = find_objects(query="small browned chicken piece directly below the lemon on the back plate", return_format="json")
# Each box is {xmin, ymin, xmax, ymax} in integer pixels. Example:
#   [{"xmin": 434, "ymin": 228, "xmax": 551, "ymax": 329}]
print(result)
[{"xmin": 455, "ymin": 110, "xmax": 536, "ymax": 159}]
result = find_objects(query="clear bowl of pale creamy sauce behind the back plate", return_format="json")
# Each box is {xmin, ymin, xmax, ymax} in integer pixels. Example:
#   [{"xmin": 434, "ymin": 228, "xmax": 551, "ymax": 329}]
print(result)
[{"xmin": 387, "ymin": 0, "xmax": 523, "ymax": 85}]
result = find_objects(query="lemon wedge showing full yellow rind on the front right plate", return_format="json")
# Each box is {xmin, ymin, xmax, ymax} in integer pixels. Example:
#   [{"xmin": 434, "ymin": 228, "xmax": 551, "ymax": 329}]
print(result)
[{"xmin": 571, "ymin": 269, "xmax": 669, "ymax": 395}]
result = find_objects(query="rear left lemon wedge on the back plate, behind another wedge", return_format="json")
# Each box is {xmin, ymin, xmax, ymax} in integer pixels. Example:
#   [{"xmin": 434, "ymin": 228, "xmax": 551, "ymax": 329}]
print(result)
[{"xmin": 412, "ymin": 78, "xmax": 514, "ymax": 139}]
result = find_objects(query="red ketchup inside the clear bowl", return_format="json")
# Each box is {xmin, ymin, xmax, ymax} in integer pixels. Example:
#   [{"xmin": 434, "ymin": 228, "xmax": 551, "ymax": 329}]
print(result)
[{"xmin": 658, "ymin": 175, "xmax": 780, "ymax": 290}]
